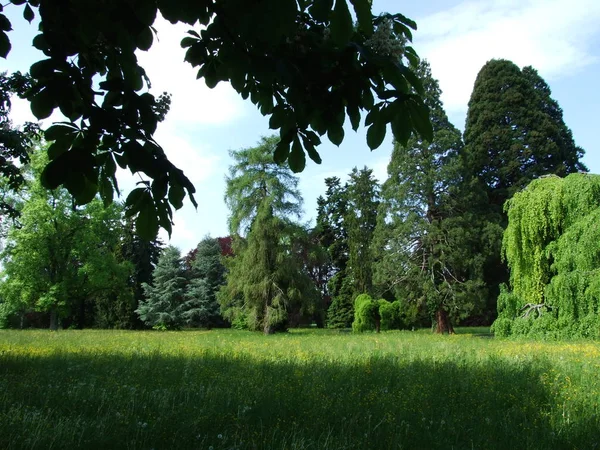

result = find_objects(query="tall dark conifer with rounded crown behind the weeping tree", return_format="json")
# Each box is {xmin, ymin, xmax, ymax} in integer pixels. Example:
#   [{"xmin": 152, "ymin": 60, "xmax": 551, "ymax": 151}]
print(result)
[{"xmin": 463, "ymin": 60, "xmax": 587, "ymax": 320}]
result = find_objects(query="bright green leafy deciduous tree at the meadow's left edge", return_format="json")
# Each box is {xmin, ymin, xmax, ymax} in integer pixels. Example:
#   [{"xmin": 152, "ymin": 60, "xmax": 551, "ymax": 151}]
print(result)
[{"xmin": 2, "ymin": 149, "xmax": 130, "ymax": 330}]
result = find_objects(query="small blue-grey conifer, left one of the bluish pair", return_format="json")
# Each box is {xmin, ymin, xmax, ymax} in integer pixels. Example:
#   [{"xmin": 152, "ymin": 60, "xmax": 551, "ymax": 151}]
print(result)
[{"xmin": 136, "ymin": 246, "xmax": 187, "ymax": 330}]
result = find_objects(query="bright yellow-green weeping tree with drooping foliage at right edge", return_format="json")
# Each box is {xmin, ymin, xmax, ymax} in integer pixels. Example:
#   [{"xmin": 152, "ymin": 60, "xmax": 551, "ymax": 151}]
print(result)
[{"xmin": 493, "ymin": 174, "xmax": 600, "ymax": 337}]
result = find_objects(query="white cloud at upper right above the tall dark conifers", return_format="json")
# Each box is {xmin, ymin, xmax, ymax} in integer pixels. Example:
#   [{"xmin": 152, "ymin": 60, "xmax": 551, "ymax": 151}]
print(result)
[{"xmin": 415, "ymin": 0, "xmax": 600, "ymax": 112}]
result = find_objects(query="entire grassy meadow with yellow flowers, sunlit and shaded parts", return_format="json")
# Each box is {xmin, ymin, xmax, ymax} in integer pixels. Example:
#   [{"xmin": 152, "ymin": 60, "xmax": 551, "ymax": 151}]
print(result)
[{"xmin": 0, "ymin": 329, "xmax": 600, "ymax": 450}]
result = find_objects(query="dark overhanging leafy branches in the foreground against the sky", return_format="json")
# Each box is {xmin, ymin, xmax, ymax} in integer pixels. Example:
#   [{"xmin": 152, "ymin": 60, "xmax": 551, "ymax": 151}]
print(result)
[{"xmin": 0, "ymin": 0, "xmax": 431, "ymax": 237}]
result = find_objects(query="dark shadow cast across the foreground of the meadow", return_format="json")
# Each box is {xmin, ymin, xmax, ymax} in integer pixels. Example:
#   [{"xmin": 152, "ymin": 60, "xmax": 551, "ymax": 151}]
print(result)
[{"xmin": 0, "ymin": 353, "xmax": 599, "ymax": 450}]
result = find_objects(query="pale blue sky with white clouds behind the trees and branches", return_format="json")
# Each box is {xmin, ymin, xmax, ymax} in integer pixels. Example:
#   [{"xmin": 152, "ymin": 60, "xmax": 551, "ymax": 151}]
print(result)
[{"xmin": 0, "ymin": 0, "xmax": 600, "ymax": 252}]
